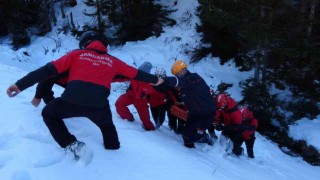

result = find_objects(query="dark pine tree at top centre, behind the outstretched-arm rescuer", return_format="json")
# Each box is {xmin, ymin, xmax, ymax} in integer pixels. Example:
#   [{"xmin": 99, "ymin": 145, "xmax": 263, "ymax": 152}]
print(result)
[{"xmin": 81, "ymin": 0, "xmax": 175, "ymax": 44}]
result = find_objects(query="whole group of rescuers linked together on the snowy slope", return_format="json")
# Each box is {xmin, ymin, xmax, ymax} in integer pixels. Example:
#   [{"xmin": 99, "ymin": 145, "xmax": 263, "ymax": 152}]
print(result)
[{"xmin": 7, "ymin": 31, "xmax": 258, "ymax": 158}]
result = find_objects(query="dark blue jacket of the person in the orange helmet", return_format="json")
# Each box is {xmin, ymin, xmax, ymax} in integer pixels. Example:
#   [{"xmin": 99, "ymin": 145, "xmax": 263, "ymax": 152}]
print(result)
[{"xmin": 165, "ymin": 71, "xmax": 216, "ymax": 117}]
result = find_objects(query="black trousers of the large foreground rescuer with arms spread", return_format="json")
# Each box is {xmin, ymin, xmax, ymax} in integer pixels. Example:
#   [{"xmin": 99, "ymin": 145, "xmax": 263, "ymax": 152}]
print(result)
[{"xmin": 42, "ymin": 98, "xmax": 120, "ymax": 149}]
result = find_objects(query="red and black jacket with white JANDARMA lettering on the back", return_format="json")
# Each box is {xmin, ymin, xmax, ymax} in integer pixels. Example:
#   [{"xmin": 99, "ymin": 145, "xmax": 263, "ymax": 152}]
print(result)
[{"xmin": 16, "ymin": 41, "xmax": 158, "ymax": 107}]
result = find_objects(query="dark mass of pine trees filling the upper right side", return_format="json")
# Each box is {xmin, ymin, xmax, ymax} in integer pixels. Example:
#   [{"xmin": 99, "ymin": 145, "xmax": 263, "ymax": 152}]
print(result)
[{"xmin": 194, "ymin": 0, "xmax": 320, "ymax": 132}]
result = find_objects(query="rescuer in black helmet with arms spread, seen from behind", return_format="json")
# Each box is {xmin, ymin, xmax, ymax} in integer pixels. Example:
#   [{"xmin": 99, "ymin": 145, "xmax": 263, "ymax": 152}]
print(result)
[{"xmin": 6, "ymin": 31, "xmax": 163, "ymax": 159}]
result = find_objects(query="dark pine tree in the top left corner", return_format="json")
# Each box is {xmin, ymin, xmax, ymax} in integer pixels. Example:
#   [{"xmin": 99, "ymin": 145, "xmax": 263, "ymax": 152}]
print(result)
[{"xmin": 0, "ymin": 0, "xmax": 51, "ymax": 49}]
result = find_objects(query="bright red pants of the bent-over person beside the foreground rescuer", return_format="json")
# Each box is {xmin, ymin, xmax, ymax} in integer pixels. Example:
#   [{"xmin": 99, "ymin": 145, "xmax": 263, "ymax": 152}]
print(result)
[{"xmin": 116, "ymin": 93, "xmax": 155, "ymax": 131}]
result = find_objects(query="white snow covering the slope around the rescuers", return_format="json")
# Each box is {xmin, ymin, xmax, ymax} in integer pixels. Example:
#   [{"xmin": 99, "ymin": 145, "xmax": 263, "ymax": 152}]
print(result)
[{"xmin": 0, "ymin": 0, "xmax": 320, "ymax": 180}]
